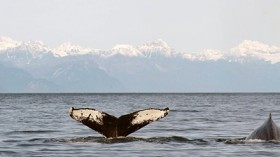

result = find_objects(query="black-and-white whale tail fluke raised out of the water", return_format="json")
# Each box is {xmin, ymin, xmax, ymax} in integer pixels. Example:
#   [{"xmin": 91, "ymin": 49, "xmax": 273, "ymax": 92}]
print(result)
[{"xmin": 69, "ymin": 107, "xmax": 169, "ymax": 138}]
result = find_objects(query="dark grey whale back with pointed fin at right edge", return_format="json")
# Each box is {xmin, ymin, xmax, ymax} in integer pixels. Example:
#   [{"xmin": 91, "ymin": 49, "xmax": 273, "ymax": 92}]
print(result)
[{"xmin": 245, "ymin": 113, "xmax": 280, "ymax": 141}]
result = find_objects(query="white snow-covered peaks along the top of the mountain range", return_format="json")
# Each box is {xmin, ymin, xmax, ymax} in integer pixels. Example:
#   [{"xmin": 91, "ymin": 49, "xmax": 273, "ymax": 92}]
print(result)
[{"xmin": 0, "ymin": 37, "xmax": 280, "ymax": 64}]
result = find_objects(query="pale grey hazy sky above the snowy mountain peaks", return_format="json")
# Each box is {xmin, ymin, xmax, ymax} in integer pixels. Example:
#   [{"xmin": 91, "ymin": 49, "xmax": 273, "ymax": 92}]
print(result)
[{"xmin": 0, "ymin": 0, "xmax": 280, "ymax": 52}]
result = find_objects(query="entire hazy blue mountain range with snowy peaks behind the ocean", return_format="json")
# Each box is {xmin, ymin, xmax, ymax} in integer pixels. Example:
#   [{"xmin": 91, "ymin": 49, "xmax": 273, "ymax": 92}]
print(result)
[{"xmin": 0, "ymin": 37, "xmax": 280, "ymax": 93}]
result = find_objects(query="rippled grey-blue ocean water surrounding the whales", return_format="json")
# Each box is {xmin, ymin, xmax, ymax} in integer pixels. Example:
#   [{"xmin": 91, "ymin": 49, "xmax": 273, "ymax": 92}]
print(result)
[{"xmin": 0, "ymin": 93, "xmax": 280, "ymax": 157}]
